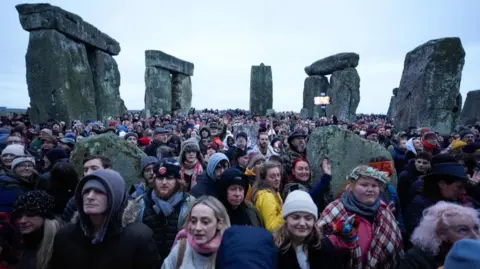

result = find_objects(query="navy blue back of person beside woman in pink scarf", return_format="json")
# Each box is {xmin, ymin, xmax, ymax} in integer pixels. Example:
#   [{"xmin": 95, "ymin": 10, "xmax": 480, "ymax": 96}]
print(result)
[{"xmin": 215, "ymin": 225, "xmax": 278, "ymax": 269}]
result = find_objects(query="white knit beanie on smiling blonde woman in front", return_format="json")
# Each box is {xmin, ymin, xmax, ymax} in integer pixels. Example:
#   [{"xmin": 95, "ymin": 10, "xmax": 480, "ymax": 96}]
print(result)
[{"xmin": 282, "ymin": 190, "xmax": 318, "ymax": 220}]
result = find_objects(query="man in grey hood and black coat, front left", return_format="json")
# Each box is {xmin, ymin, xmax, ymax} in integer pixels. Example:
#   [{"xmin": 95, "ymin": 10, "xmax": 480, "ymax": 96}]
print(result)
[{"xmin": 50, "ymin": 170, "xmax": 159, "ymax": 269}]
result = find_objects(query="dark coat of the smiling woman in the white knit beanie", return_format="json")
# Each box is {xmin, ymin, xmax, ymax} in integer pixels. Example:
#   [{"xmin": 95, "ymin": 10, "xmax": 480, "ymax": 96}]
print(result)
[{"xmin": 278, "ymin": 238, "xmax": 349, "ymax": 269}]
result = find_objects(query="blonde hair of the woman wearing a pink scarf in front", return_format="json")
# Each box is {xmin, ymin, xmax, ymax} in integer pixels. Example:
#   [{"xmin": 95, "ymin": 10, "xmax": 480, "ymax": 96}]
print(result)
[{"xmin": 183, "ymin": 196, "xmax": 230, "ymax": 269}]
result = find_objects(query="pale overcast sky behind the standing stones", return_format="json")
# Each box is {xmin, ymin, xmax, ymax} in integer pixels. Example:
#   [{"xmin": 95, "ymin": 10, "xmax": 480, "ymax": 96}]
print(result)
[{"xmin": 0, "ymin": 0, "xmax": 480, "ymax": 113}]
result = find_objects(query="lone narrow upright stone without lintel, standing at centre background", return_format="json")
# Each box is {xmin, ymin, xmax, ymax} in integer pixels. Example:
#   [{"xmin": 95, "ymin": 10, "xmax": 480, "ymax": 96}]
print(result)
[{"xmin": 250, "ymin": 63, "xmax": 273, "ymax": 116}]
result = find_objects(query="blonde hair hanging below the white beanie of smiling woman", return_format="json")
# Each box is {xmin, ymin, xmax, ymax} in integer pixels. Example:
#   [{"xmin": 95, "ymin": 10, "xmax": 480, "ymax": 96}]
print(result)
[{"xmin": 273, "ymin": 222, "xmax": 323, "ymax": 254}]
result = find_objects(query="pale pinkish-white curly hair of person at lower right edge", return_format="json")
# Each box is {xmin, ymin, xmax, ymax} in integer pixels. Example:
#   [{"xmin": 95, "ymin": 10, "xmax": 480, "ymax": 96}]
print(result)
[{"xmin": 410, "ymin": 201, "xmax": 480, "ymax": 255}]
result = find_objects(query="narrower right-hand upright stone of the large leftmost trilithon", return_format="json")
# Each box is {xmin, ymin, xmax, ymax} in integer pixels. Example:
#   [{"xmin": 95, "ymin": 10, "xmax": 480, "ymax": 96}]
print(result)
[{"xmin": 88, "ymin": 50, "xmax": 127, "ymax": 122}]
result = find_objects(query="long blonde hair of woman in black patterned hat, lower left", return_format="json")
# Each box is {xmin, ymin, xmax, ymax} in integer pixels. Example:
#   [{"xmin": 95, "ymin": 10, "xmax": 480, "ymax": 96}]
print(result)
[{"xmin": 36, "ymin": 219, "xmax": 62, "ymax": 269}]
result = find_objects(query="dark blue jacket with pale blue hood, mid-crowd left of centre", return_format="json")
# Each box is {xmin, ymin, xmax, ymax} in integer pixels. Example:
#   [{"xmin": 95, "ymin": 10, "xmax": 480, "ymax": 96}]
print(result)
[{"xmin": 190, "ymin": 153, "xmax": 228, "ymax": 198}]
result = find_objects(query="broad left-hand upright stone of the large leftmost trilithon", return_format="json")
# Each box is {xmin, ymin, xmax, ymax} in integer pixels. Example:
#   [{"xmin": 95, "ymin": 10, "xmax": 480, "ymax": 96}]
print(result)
[{"xmin": 25, "ymin": 30, "xmax": 97, "ymax": 123}]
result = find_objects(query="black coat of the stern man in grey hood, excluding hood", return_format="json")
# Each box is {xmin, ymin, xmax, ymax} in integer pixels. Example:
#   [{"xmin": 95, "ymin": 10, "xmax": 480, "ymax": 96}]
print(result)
[{"xmin": 49, "ymin": 215, "xmax": 159, "ymax": 269}]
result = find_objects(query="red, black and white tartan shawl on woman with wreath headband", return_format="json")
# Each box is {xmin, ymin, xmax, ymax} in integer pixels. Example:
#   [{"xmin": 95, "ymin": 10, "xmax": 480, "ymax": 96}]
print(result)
[{"xmin": 317, "ymin": 199, "xmax": 403, "ymax": 269}]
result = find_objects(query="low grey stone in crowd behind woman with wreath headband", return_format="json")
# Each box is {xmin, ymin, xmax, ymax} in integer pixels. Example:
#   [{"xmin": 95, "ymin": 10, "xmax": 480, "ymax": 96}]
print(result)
[{"xmin": 307, "ymin": 126, "xmax": 397, "ymax": 194}]
